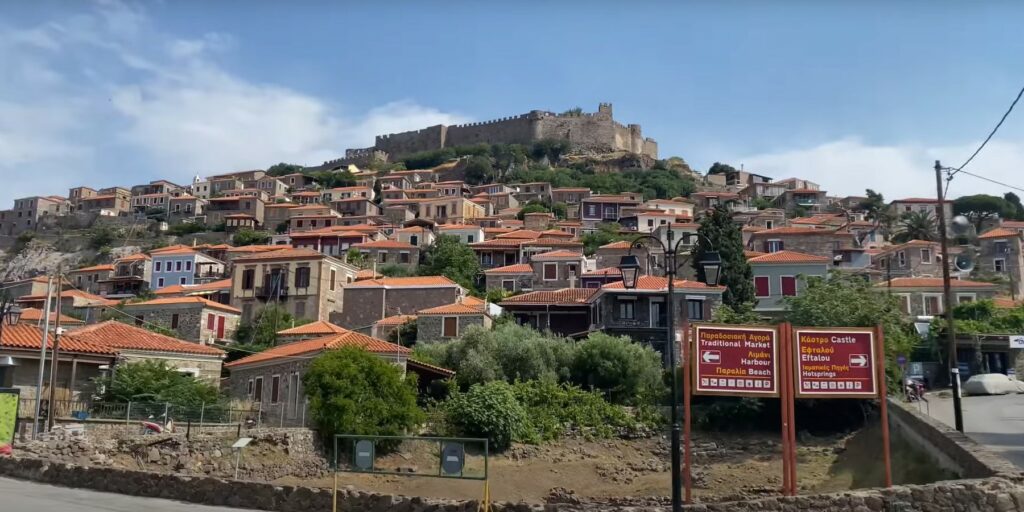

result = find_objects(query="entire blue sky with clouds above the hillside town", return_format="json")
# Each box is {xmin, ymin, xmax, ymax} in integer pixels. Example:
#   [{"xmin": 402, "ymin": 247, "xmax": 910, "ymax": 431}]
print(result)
[{"xmin": 0, "ymin": 0, "xmax": 1024, "ymax": 208}]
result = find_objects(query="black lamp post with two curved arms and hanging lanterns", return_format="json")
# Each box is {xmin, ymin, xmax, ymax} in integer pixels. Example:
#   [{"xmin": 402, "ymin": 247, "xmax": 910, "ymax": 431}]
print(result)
[{"xmin": 618, "ymin": 226, "xmax": 722, "ymax": 512}]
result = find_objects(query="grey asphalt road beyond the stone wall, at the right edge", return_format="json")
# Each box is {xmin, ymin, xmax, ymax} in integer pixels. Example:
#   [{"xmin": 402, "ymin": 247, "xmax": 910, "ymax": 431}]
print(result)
[{"xmin": 928, "ymin": 394, "xmax": 1024, "ymax": 469}]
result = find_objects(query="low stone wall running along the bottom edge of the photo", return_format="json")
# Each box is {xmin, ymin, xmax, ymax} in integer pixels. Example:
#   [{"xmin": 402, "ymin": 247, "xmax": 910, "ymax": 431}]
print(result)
[{"xmin": 0, "ymin": 458, "xmax": 1024, "ymax": 512}]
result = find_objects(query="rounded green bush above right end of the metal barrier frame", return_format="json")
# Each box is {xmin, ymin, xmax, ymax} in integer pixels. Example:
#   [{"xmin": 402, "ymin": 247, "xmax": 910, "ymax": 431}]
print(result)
[{"xmin": 443, "ymin": 382, "xmax": 536, "ymax": 451}]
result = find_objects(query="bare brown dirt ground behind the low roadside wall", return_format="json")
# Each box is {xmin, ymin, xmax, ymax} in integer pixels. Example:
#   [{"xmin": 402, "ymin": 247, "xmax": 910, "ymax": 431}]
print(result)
[{"xmin": 276, "ymin": 432, "xmax": 879, "ymax": 503}]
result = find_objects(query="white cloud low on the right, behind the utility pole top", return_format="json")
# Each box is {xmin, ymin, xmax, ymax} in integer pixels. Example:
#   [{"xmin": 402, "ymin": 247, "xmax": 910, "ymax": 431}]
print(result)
[{"xmin": 725, "ymin": 137, "xmax": 1024, "ymax": 199}]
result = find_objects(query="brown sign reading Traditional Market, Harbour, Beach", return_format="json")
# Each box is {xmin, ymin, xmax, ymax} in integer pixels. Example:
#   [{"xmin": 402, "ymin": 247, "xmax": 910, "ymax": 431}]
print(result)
[{"xmin": 693, "ymin": 325, "xmax": 779, "ymax": 396}]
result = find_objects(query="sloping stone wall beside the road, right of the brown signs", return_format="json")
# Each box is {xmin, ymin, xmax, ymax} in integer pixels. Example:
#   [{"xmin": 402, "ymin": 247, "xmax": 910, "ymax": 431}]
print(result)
[{"xmin": 889, "ymin": 398, "xmax": 1024, "ymax": 478}]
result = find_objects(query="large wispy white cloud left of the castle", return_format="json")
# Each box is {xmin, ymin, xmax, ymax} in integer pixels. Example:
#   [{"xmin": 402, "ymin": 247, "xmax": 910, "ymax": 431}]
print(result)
[{"xmin": 0, "ymin": 0, "xmax": 468, "ymax": 205}]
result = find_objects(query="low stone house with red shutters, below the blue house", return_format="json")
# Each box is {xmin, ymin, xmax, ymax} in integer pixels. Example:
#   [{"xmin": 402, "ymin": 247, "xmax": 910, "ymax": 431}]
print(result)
[{"xmin": 122, "ymin": 296, "xmax": 242, "ymax": 345}]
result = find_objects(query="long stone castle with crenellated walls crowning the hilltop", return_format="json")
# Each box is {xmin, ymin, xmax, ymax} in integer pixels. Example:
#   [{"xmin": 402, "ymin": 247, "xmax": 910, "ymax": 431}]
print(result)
[{"xmin": 335, "ymin": 103, "xmax": 657, "ymax": 165}]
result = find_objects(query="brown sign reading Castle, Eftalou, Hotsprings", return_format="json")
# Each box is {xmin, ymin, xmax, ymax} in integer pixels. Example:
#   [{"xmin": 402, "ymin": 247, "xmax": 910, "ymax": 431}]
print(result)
[{"xmin": 794, "ymin": 328, "xmax": 876, "ymax": 398}]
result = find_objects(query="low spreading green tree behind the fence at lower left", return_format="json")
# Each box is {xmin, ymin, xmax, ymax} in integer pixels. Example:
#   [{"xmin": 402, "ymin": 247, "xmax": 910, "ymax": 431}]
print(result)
[{"xmin": 97, "ymin": 360, "xmax": 222, "ymax": 406}]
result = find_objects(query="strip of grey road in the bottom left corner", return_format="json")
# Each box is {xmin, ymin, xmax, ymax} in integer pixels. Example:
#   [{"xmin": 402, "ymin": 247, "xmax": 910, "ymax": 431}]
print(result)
[{"xmin": 0, "ymin": 478, "xmax": 262, "ymax": 512}]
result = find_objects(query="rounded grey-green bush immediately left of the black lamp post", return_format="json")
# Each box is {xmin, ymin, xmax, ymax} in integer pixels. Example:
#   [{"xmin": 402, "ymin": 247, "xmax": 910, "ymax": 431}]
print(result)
[{"xmin": 571, "ymin": 333, "xmax": 665, "ymax": 403}]
